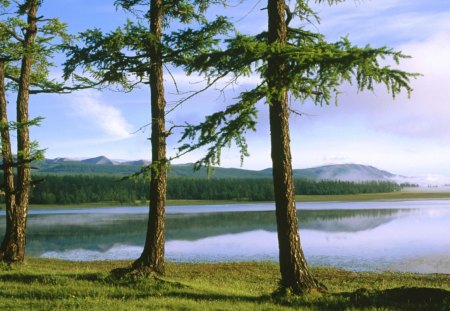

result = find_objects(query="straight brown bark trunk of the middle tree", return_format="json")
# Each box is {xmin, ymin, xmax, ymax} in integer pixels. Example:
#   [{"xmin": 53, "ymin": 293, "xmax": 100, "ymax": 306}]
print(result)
[{"xmin": 133, "ymin": 0, "xmax": 167, "ymax": 274}]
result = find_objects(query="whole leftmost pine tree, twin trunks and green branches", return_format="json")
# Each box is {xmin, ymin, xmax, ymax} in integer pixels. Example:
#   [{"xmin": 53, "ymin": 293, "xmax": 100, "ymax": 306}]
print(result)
[{"xmin": 0, "ymin": 0, "xmax": 69, "ymax": 262}]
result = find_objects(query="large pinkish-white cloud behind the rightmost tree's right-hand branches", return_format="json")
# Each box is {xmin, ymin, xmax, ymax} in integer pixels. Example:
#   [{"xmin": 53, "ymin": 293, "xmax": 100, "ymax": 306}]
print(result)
[{"xmin": 296, "ymin": 33, "xmax": 450, "ymax": 142}]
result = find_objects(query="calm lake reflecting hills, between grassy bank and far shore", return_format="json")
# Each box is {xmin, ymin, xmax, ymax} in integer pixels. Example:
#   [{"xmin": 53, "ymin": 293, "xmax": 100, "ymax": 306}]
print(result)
[{"xmin": 0, "ymin": 200, "xmax": 450, "ymax": 273}]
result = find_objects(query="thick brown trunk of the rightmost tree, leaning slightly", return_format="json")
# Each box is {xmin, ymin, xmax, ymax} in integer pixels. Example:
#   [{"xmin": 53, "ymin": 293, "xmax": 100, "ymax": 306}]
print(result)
[{"xmin": 267, "ymin": 0, "xmax": 318, "ymax": 294}]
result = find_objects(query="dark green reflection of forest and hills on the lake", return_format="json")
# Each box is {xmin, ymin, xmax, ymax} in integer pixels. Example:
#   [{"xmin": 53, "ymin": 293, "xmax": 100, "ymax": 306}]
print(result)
[{"xmin": 22, "ymin": 210, "xmax": 406, "ymax": 256}]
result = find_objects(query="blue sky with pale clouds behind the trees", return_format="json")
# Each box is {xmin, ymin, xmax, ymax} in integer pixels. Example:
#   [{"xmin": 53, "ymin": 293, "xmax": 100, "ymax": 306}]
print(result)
[{"xmin": 6, "ymin": 0, "xmax": 450, "ymax": 182}]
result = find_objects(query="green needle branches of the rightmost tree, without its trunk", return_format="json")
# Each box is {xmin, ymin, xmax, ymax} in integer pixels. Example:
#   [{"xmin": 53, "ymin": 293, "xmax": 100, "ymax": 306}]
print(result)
[{"xmin": 179, "ymin": 1, "xmax": 418, "ymax": 167}]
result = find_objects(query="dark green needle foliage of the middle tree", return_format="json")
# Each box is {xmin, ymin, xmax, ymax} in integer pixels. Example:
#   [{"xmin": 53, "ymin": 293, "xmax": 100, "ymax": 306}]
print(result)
[{"xmin": 64, "ymin": 0, "xmax": 231, "ymax": 91}]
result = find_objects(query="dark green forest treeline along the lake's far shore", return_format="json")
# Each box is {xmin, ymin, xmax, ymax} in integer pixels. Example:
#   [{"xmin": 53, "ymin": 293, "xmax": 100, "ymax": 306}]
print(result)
[{"xmin": 0, "ymin": 175, "xmax": 402, "ymax": 204}]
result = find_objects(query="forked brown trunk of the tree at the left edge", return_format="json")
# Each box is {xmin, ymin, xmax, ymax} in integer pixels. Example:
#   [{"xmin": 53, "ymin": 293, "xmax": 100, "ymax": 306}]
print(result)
[{"xmin": 0, "ymin": 0, "xmax": 40, "ymax": 262}]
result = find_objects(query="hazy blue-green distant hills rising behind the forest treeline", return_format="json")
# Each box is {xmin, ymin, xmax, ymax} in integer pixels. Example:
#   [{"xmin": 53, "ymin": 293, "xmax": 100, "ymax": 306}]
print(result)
[{"xmin": 33, "ymin": 156, "xmax": 396, "ymax": 181}]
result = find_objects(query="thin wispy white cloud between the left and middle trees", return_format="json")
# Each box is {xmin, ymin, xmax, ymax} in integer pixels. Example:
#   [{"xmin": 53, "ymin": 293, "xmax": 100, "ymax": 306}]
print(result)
[{"xmin": 71, "ymin": 91, "xmax": 132, "ymax": 139}]
